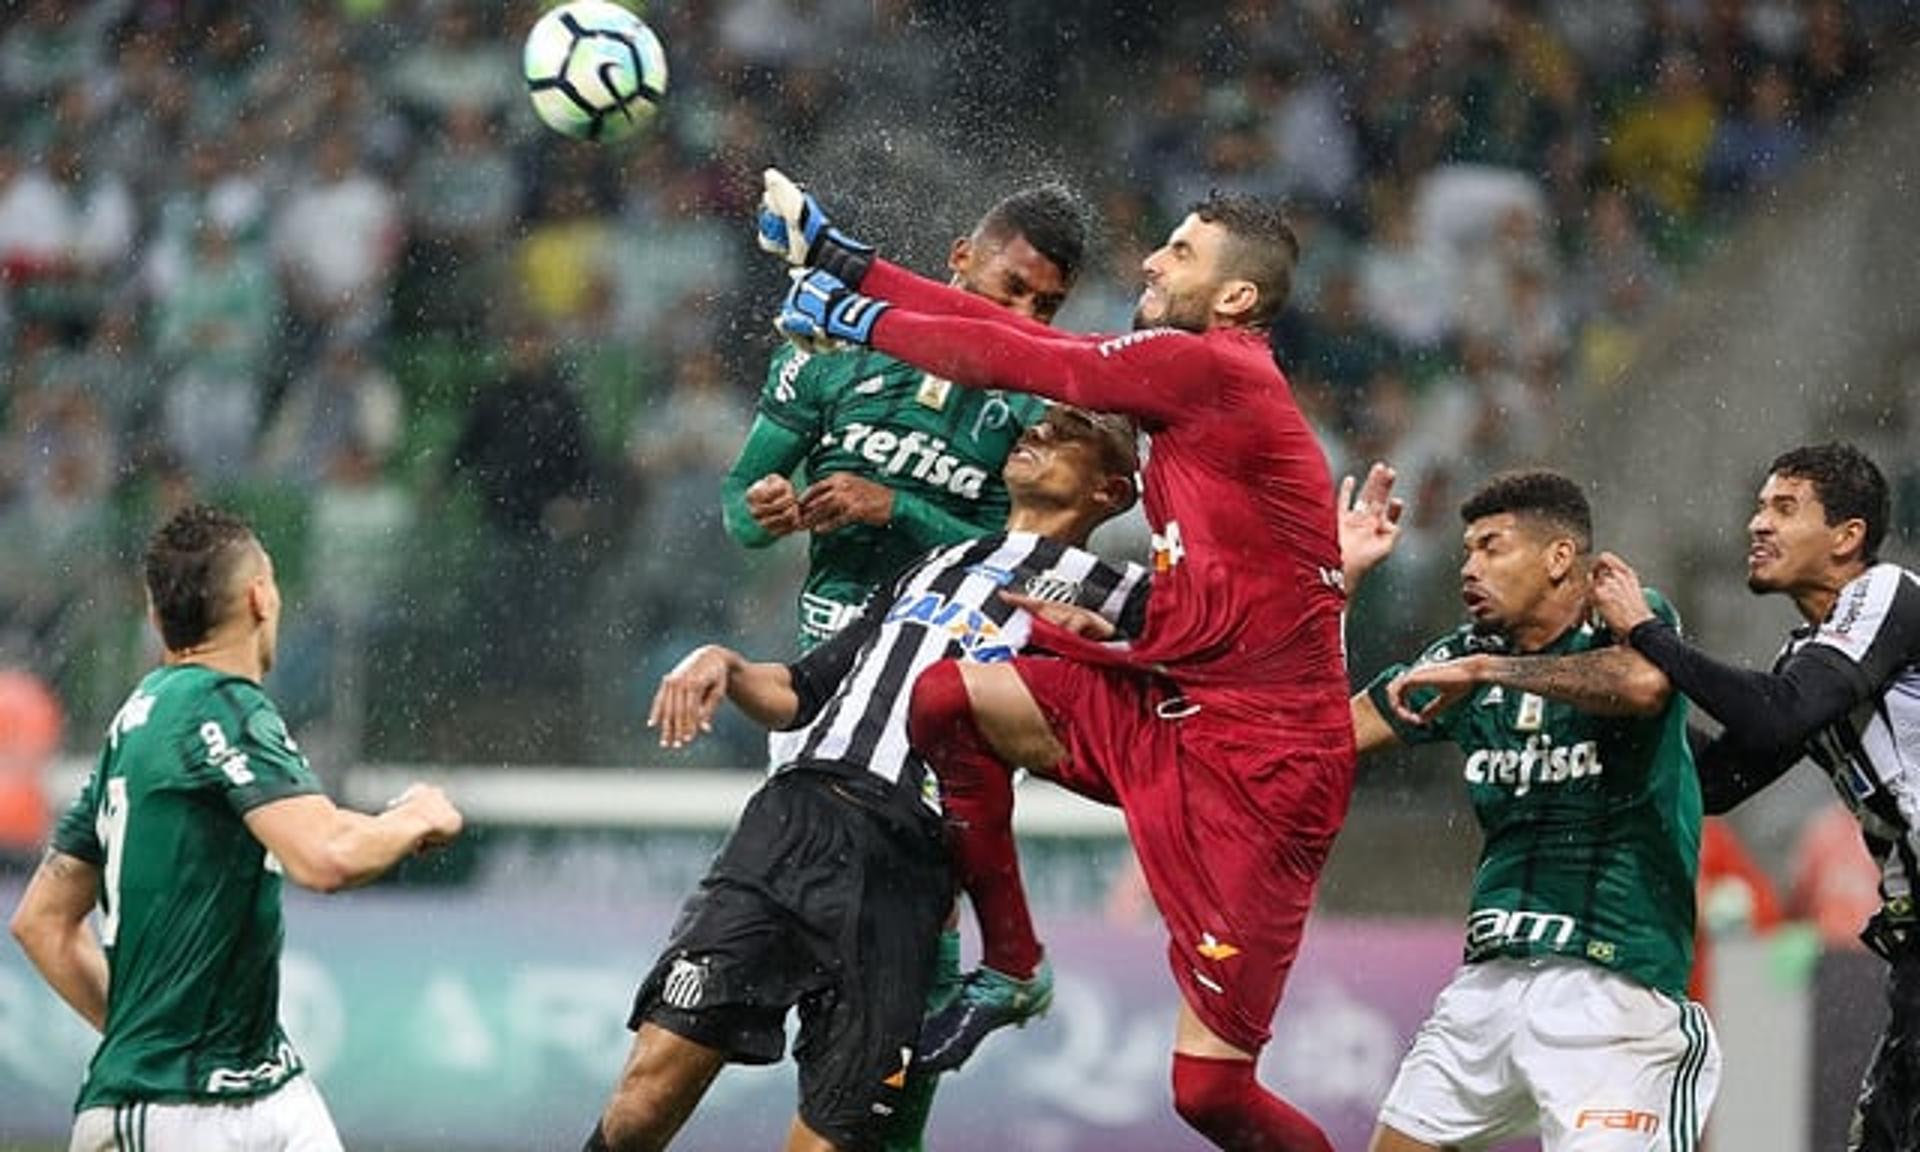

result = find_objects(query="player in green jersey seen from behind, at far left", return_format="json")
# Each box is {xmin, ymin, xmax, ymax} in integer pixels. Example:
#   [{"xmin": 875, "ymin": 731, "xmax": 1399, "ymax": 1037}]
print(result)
[{"xmin": 12, "ymin": 505, "xmax": 461, "ymax": 1152}]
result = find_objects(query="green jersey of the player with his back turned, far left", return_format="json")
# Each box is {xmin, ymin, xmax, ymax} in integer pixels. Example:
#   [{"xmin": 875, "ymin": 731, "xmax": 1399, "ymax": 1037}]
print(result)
[{"xmin": 54, "ymin": 664, "xmax": 321, "ymax": 1110}]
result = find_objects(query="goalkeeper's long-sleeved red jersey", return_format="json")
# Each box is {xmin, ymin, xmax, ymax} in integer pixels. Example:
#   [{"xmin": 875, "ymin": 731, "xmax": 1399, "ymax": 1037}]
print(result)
[{"xmin": 860, "ymin": 261, "xmax": 1352, "ymax": 732}]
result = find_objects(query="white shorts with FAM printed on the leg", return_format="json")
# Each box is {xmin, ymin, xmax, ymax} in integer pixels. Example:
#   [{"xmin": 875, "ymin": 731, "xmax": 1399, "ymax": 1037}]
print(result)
[{"xmin": 1380, "ymin": 958, "xmax": 1720, "ymax": 1152}]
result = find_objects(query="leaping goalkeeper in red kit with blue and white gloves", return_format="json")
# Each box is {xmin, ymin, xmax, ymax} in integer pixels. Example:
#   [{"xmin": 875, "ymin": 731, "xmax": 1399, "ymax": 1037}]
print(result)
[{"xmin": 760, "ymin": 171, "xmax": 1354, "ymax": 1152}]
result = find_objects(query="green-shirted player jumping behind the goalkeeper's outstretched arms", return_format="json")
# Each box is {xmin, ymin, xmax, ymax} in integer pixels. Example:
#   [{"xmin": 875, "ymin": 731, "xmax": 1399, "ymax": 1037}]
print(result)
[{"xmin": 722, "ymin": 184, "xmax": 1087, "ymax": 651}]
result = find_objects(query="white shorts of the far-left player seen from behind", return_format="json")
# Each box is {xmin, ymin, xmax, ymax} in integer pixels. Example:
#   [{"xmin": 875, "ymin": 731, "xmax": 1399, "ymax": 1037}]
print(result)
[{"xmin": 67, "ymin": 1075, "xmax": 342, "ymax": 1152}]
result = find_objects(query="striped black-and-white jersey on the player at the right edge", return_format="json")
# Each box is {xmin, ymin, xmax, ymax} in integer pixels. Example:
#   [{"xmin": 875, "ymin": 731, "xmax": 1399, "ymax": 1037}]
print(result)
[{"xmin": 1774, "ymin": 564, "xmax": 1920, "ymax": 916}]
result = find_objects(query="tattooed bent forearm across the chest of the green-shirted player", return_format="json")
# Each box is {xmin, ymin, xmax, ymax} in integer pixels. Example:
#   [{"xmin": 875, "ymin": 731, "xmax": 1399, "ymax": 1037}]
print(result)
[{"xmin": 1386, "ymin": 647, "xmax": 1672, "ymax": 724}]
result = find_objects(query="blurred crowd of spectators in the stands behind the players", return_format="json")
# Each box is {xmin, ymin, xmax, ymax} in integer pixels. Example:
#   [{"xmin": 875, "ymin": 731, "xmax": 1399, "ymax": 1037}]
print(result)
[{"xmin": 0, "ymin": 0, "xmax": 1912, "ymax": 764}]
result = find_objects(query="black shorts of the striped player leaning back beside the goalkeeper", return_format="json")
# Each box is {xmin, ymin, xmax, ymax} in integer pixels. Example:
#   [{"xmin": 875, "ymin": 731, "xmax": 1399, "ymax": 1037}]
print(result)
[{"xmin": 628, "ymin": 768, "xmax": 952, "ymax": 1150}]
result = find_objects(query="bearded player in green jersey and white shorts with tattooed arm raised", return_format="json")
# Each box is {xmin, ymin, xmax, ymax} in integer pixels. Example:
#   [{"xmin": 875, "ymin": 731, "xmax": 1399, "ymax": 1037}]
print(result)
[{"xmin": 1354, "ymin": 470, "xmax": 1720, "ymax": 1152}]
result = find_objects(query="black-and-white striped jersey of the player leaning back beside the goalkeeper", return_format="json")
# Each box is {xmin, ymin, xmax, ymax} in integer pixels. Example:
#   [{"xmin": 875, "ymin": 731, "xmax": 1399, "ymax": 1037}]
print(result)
[{"xmin": 776, "ymin": 532, "xmax": 1148, "ymax": 812}]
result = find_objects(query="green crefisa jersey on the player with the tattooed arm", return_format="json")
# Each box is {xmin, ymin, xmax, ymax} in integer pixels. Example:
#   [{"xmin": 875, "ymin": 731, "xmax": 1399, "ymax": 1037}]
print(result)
[{"xmin": 1367, "ymin": 591, "xmax": 1701, "ymax": 998}]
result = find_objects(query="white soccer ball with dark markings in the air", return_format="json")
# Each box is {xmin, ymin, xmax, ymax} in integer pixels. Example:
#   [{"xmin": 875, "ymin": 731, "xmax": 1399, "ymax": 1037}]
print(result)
[{"xmin": 522, "ymin": 0, "xmax": 666, "ymax": 140}]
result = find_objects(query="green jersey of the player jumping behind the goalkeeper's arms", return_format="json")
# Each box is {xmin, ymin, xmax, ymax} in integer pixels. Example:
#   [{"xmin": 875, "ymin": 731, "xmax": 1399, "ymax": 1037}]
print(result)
[{"xmin": 724, "ymin": 346, "xmax": 1046, "ymax": 649}]
